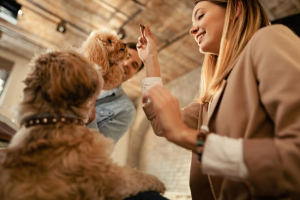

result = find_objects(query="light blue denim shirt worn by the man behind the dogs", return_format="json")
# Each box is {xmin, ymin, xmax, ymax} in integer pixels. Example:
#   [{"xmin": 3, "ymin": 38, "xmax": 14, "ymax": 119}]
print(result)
[{"xmin": 87, "ymin": 86, "xmax": 136, "ymax": 144}]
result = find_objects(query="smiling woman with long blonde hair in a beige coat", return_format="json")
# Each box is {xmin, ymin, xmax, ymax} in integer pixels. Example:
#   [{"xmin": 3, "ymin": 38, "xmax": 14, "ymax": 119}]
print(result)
[{"xmin": 137, "ymin": 0, "xmax": 300, "ymax": 200}]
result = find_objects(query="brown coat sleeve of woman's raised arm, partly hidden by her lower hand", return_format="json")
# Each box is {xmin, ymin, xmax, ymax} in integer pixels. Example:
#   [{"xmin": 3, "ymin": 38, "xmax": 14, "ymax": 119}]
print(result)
[{"xmin": 143, "ymin": 102, "xmax": 200, "ymax": 136}]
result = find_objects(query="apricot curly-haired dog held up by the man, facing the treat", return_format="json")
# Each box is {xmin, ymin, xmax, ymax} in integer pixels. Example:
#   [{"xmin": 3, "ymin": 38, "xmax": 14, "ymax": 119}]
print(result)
[{"xmin": 81, "ymin": 28, "xmax": 128, "ymax": 90}]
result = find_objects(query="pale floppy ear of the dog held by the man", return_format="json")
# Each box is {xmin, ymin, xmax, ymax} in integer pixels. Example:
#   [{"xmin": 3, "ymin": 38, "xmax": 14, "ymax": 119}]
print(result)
[{"xmin": 81, "ymin": 31, "xmax": 109, "ymax": 73}]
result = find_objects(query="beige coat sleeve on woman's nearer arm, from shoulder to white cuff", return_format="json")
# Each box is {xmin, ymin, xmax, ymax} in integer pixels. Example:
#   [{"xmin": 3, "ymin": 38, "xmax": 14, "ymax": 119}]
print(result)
[{"xmin": 243, "ymin": 25, "xmax": 300, "ymax": 199}]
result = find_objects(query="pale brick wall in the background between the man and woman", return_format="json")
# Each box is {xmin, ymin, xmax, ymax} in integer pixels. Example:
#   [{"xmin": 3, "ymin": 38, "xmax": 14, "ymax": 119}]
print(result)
[{"xmin": 127, "ymin": 68, "xmax": 200, "ymax": 199}]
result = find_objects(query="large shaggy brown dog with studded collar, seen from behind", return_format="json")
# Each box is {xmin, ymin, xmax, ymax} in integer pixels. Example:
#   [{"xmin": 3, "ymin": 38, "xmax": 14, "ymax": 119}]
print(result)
[{"xmin": 0, "ymin": 51, "xmax": 165, "ymax": 200}]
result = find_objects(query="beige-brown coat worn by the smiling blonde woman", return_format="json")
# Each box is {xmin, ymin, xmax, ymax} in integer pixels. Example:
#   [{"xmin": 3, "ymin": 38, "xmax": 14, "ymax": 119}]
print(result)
[{"xmin": 144, "ymin": 25, "xmax": 300, "ymax": 200}]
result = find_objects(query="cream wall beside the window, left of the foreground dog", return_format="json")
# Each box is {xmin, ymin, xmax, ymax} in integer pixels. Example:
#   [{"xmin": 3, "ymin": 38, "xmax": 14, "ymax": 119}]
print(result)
[{"xmin": 0, "ymin": 48, "xmax": 29, "ymax": 122}]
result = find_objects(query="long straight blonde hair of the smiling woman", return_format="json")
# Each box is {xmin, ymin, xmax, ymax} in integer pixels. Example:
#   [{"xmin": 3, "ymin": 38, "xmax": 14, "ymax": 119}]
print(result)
[{"xmin": 195, "ymin": 0, "xmax": 270, "ymax": 103}]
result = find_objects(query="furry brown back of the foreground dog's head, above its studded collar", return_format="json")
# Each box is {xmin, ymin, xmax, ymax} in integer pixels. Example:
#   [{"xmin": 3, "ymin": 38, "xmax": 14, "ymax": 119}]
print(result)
[{"xmin": 23, "ymin": 51, "xmax": 103, "ymax": 110}]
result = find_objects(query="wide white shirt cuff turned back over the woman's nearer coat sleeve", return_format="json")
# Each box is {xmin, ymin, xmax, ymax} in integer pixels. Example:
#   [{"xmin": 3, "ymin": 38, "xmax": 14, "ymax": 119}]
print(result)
[{"xmin": 202, "ymin": 134, "xmax": 248, "ymax": 181}]
